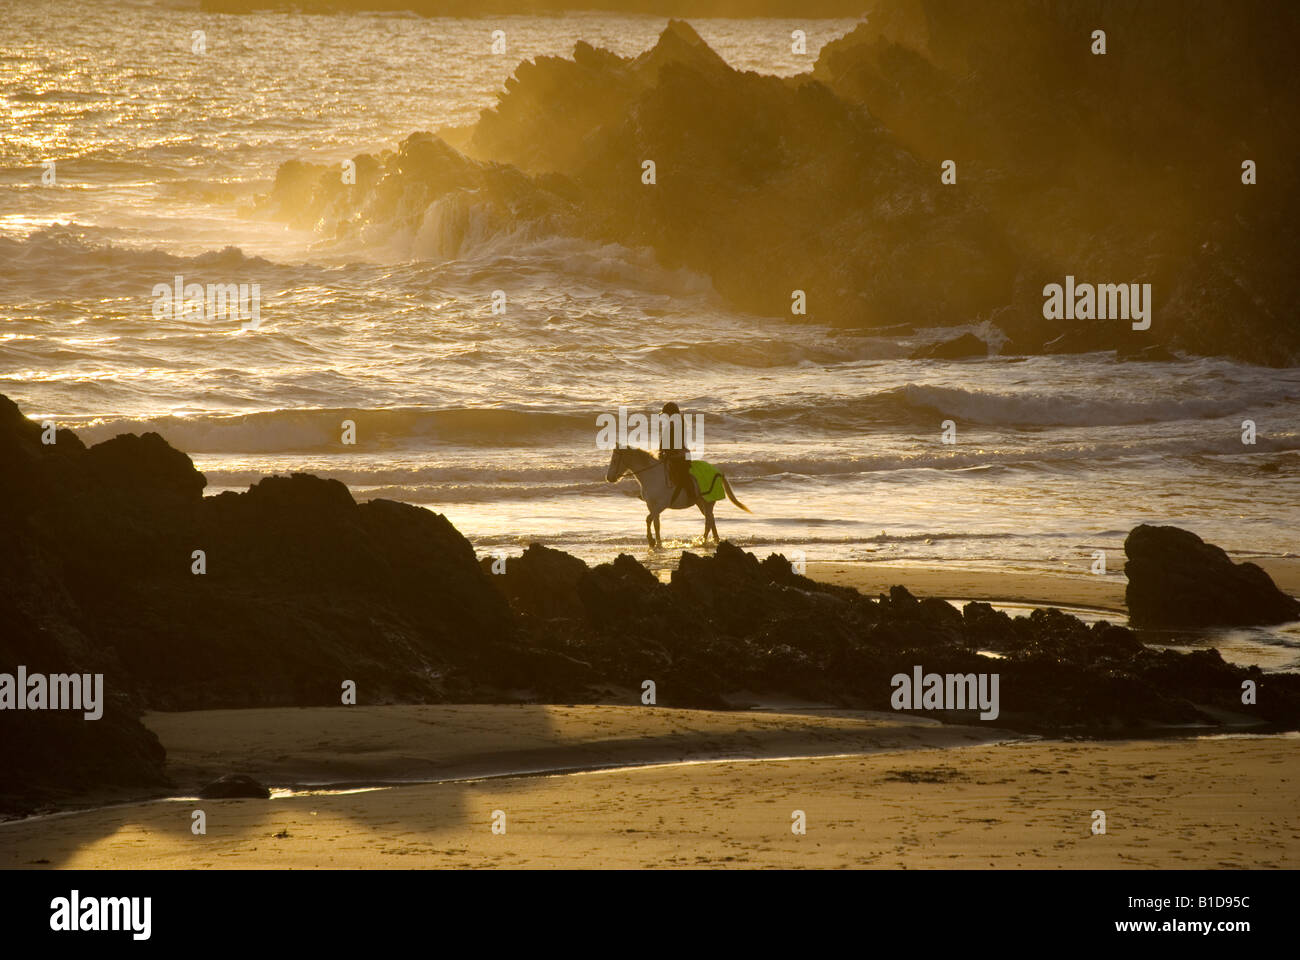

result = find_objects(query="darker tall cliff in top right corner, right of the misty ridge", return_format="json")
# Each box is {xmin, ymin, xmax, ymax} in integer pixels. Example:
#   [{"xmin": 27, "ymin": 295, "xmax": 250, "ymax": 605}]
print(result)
[{"xmin": 813, "ymin": 0, "xmax": 1300, "ymax": 366}]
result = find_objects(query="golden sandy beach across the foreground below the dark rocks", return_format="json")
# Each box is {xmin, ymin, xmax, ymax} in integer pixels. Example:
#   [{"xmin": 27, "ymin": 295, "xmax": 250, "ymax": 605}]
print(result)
[{"xmin": 0, "ymin": 705, "xmax": 1300, "ymax": 869}]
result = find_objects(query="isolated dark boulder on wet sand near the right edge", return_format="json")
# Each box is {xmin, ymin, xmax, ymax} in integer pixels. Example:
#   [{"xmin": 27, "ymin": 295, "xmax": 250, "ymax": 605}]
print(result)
[{"xmin": 1125, "ymin": 523, "xmax": 1300, "ymax": 627}]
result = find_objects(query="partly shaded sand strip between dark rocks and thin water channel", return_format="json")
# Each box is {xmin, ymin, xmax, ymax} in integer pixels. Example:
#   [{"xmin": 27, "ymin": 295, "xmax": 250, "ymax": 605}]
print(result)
[{"xmin": 0, "ymin": 691, "xmax": 1013, "ymax": 830}]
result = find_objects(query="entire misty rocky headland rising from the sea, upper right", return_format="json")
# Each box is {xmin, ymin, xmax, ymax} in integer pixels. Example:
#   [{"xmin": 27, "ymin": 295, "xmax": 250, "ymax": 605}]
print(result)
[{"xmin": 256, "ymin": 7, "xmax": 1300, "ymax": 366}]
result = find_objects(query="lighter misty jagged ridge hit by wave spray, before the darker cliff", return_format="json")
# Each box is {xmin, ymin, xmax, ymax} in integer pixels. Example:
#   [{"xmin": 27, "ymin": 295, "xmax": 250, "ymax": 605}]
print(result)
[{"xmin": 267, "ymin": 21, "xmax": 1014, "ymax": 328}]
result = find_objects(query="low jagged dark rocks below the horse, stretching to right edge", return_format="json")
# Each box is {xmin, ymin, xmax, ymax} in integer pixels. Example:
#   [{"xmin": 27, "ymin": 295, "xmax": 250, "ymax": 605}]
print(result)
[{"xmin": 486, "ymin": 542, "xmax": 1300, "ymax": 734}]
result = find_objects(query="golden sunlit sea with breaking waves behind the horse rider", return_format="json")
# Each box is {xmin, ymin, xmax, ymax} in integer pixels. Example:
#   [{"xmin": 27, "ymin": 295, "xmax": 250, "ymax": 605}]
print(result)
[{"xmin": 0, "ymin": 0, "xmax": 1300, "ymax": 629}]
